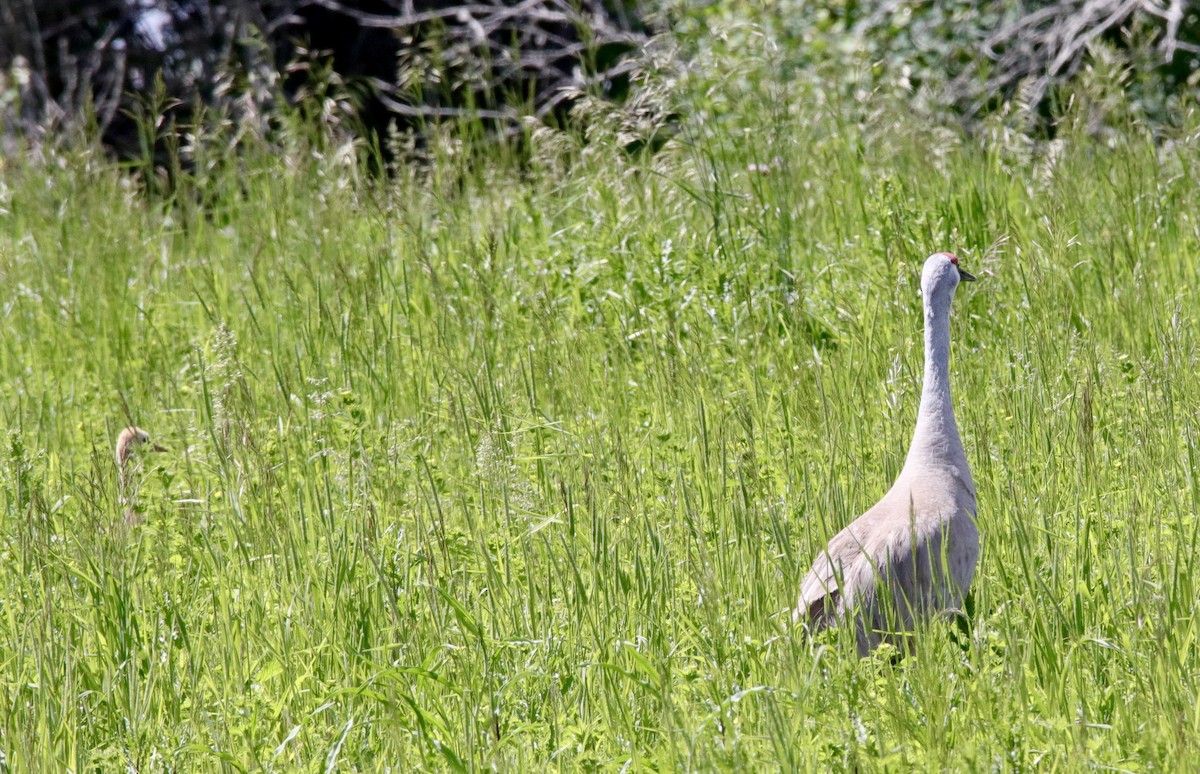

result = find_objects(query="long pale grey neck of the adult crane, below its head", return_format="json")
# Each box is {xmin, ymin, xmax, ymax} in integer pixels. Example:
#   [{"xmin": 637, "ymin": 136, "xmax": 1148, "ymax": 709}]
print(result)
[{"xmin": 905, "ymin": 295, "xmax": 965, "ymax": 468}]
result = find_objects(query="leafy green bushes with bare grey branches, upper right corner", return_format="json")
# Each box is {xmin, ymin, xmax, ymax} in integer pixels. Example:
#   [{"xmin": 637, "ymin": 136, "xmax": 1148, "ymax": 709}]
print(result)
[{"xmin": 780, "ymin": 0, "xmax": 1200, "ymax": 132}]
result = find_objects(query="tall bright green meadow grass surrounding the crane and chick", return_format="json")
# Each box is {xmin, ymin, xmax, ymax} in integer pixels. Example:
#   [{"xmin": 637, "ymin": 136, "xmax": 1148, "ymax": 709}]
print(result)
[{"xmin": 0, "ymin": 21, "xmax": 1200, "ymax": 772}]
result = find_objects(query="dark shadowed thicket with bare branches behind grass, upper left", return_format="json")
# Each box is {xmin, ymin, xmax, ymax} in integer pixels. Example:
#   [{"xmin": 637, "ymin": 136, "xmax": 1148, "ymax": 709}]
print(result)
[{"xmin": 0, "ymin": 0, "xmax": 653, "ymax": 156}]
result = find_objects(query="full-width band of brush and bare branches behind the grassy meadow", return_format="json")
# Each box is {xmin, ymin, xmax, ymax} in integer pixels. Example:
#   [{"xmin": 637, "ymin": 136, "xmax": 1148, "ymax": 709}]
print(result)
[{"xmin": 0, "ymin": 0, "xmax": 1200, "ymax": 161}]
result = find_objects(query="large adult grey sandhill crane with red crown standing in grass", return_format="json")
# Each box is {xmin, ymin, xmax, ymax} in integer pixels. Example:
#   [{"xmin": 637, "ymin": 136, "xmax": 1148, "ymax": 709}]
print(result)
[{"xmin": 793, "ymin": 253, "xmax": 979, "ymax": 655}]
